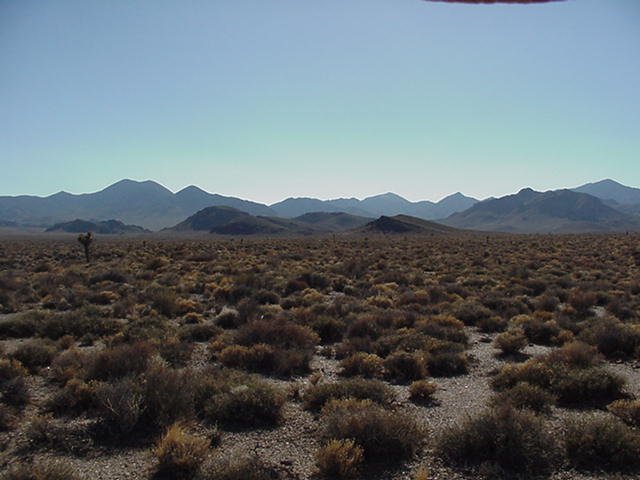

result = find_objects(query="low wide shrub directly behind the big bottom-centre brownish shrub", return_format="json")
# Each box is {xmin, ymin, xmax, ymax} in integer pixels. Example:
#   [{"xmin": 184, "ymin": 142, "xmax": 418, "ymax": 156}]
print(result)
[{"xmin": 304, "ymin": 378, "xmax": 393, "ymax": 410}]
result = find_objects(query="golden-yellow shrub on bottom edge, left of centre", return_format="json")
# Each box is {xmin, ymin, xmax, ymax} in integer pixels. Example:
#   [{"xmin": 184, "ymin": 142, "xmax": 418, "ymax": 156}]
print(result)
[{"xmin": 153, "ymin": 423, "xmax": 209, "ymax": 479}]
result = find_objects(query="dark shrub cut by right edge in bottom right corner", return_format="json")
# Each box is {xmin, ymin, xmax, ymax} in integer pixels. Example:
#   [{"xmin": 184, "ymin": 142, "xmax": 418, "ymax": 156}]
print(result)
[{"xmin": 565, "ymin": 415, "xmax": 640, "ymax": 471}]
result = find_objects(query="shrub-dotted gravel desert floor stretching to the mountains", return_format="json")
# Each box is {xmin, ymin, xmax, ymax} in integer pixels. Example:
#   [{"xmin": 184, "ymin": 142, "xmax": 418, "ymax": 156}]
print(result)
[{"xmin": 0, "ymin": 235, "xmax": 640, "ymax": 480}]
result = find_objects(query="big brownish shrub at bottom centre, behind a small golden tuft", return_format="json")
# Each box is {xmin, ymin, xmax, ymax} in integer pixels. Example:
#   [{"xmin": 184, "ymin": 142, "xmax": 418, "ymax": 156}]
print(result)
[{"xmin": 322, "ymin": 399, "xmax": 426, "ymax": 462}]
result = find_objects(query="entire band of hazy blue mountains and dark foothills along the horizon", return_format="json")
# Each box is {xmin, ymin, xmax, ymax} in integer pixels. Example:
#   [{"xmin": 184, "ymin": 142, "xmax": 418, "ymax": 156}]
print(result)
[{"xmin": 0, "ymin": 179, "xmax": 640, "ymax": 235}]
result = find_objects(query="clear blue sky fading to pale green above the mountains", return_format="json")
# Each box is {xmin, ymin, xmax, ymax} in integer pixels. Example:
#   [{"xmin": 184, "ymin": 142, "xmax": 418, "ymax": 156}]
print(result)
[{"xmin": 0, "ymin": 0, "xmax": 640, "ymax": 203}]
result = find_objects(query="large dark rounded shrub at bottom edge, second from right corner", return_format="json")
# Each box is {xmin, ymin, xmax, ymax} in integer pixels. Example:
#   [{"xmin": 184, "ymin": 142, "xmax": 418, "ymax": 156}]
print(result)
[{"xmin": 436, "ymin": 406, "xmax": 558, "ymax": 478}]
